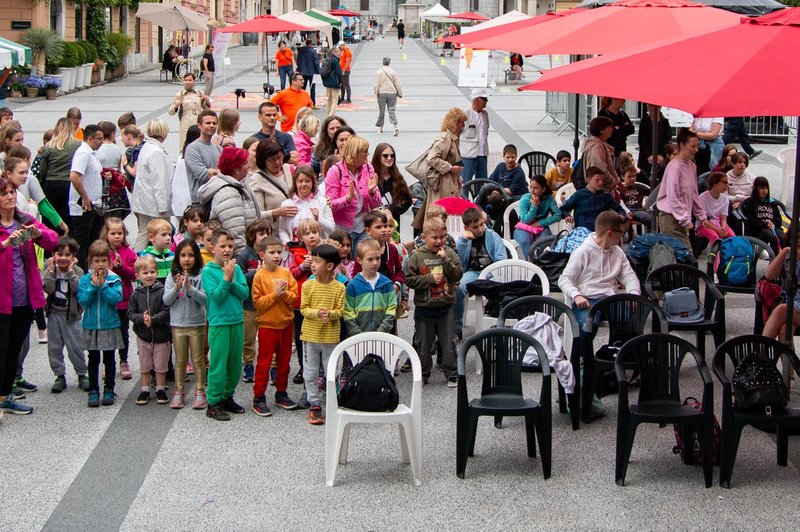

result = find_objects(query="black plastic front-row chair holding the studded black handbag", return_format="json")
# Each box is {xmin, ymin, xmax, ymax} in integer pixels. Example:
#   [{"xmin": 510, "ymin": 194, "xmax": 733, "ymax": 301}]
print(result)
[{"xmin": 713, "ymin": 335, "xmax": 800, "ymax": 488}]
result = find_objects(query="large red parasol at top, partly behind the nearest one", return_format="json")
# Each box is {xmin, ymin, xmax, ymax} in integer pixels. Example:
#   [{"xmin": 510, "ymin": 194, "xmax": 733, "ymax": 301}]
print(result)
[{"xmin": 444, "ymin": 0, "xmax": 741, "ymax": 55}]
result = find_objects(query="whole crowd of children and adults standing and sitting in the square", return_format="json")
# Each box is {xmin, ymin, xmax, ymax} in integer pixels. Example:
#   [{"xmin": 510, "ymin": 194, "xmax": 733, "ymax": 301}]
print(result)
[{"xmin": 0, "ymin": 60, "xmax": 786, "ymax": 424}]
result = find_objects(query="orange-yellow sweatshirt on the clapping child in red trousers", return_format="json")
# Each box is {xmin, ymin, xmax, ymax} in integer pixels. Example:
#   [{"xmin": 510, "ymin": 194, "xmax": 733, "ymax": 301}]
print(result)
[{"xmin": 252, "ymin": 266, "xmax": 297, "ymax": 329}]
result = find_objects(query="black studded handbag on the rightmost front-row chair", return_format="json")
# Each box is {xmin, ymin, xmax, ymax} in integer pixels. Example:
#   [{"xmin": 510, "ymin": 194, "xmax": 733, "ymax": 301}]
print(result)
[{"xmin": 731, "ymin": 353, "xmax": 789, "ymax": 416}]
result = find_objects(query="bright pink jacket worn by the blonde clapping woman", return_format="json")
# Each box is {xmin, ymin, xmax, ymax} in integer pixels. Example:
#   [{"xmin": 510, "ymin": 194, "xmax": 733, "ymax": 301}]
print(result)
[{"xmin": 325, "ymin": 161, "xmax": 381, "ymax": 227}]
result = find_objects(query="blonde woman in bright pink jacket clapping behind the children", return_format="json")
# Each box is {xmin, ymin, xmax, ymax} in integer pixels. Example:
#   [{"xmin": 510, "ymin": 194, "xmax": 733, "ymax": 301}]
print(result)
[{"xmin": 325, "ymin": 136, "xmax": 381, "ymax": 255}]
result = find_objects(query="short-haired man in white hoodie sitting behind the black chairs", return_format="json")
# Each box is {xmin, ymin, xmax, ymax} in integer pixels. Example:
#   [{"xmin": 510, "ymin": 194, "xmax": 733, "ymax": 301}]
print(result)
[{"xmin": 558, "ymin": 211, "xmax": 641, "ymax": 335}]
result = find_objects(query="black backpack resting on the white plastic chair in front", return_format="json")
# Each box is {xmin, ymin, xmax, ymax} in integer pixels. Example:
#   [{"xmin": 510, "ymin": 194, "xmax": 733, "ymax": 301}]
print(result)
[{"xmin": 339, "ymin": 353, "xmax": 400, "ymax": 412}]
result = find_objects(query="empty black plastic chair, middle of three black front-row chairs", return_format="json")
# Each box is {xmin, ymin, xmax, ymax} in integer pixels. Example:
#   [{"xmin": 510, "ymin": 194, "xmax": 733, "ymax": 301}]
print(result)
[{"xmin": 615, "ymin": 334, "xmax": 714, "ymax": 488}]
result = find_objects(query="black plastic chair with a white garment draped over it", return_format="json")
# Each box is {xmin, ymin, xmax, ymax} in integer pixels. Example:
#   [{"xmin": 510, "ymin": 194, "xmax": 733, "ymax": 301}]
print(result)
[{"xmin": 497, "ymin": 296, "xmax": 581, "ymax": 430}]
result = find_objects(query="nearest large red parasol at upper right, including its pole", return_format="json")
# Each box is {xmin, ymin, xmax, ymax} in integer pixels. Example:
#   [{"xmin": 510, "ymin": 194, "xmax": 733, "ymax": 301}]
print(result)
[{"xmin": 520, "ymin": 8, "xmax": 800, "ymax": 341}]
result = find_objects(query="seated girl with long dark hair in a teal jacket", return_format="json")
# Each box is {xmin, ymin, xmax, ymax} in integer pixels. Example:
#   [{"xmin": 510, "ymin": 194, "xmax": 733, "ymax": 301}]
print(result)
[{"xmin": 514, "ymin": 174, "xmax": 561, "ymax": 257}]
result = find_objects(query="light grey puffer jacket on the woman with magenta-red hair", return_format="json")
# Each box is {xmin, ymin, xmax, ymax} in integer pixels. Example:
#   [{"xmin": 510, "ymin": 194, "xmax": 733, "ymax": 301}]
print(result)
[{"xmin": 197, "ymin": 174, "xmax": 261, "ymax": 253}]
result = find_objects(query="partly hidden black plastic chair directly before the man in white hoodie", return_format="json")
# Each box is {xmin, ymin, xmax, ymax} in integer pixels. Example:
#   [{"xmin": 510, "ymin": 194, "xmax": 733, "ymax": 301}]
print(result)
[{"xmin": 581, "ymin": 294, "xmax": 667, "ymax": 421}]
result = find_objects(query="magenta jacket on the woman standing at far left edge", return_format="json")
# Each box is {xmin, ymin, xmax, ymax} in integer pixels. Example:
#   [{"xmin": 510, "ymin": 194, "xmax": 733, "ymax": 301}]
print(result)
[{"xmin": 0, "ymin": 211, "xmax": 58, "ymax": 315}]
